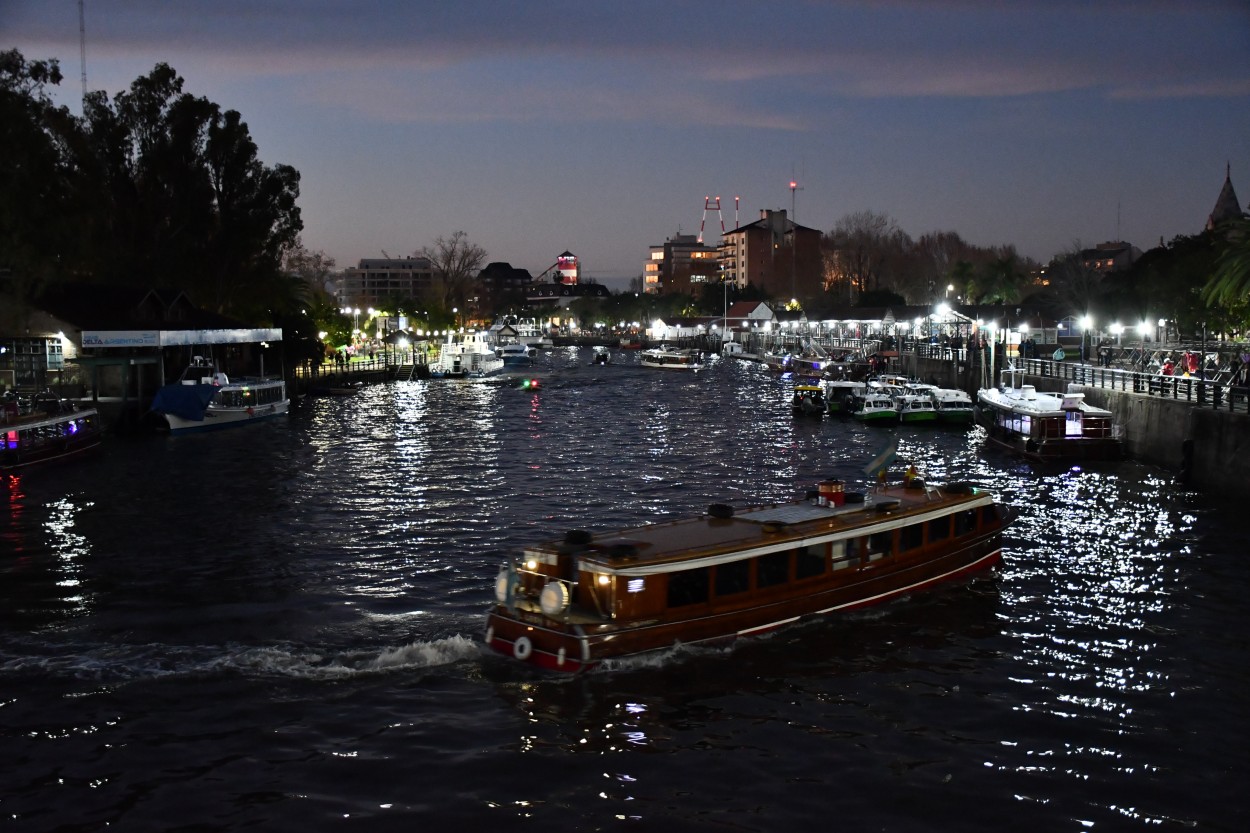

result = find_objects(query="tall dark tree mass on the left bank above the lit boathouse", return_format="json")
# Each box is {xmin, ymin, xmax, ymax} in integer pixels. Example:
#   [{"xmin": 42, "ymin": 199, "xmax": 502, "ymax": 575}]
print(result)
[{"xmin": 0, "ymin": 51, "xmax": 303, "ymax": 323}]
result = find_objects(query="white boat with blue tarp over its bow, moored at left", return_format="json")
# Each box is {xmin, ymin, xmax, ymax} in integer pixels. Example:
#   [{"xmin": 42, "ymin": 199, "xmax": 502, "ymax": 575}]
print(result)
[{"xmin": 151, "ymin": 356, "xmax": 291, "ymax": 434}]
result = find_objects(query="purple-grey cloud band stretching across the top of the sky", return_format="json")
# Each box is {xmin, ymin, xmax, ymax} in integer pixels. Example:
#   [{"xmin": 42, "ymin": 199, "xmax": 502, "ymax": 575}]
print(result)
[{"xmin": 6, "ymin": 0, "xmax": 1250, "ymax": 131}]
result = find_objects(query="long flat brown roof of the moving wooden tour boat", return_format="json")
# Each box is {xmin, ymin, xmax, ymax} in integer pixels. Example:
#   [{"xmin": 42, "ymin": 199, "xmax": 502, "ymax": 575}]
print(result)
[{"xmin": 526, "ymin": 484, "xmax": 994, "ymax": 575}]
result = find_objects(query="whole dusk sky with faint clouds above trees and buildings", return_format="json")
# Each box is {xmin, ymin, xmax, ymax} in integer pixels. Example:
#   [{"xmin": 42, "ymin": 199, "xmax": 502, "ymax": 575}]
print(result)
[{"xmin": 0, "ymin": 0, "xmax": 1250, "ymax": 289}]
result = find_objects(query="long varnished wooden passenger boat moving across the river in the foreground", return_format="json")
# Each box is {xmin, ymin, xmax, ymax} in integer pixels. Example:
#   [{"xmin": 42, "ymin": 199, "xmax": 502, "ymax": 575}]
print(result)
[{"xmin": 485, "ymin": 470, "xmax": 1011, "ymax": 672}]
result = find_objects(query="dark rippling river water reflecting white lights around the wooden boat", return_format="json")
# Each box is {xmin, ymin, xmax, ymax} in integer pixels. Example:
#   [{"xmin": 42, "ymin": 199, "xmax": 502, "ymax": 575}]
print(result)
[{"xmin": 0, "ymin": 349, "xmax": 1250, "ymax": 832}]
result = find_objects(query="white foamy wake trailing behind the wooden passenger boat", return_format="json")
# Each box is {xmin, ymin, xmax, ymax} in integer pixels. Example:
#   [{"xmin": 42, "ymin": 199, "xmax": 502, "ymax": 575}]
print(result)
[{"xmin": 0, "ymin": 635, "xmax": 480, "ymax": 682}]
